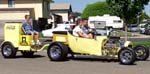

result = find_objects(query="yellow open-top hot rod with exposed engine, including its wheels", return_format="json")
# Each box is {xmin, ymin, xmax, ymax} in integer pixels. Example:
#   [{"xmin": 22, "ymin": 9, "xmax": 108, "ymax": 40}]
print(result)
[{"xmin": 47, "ymin": 31, "xmax": 149, "ymax": 65}]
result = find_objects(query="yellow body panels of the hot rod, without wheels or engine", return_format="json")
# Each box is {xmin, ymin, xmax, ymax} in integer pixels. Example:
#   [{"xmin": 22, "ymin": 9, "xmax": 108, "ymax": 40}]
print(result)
[{"xmin": 53, "ymin": 32, "xmax": 132, "ymax": 58}]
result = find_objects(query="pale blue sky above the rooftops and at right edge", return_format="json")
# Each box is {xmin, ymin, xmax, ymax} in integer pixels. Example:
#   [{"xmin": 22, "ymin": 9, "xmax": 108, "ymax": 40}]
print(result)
[{"xmin": 54, "ymin": 0, "xmax": 150, "ymax": 16}]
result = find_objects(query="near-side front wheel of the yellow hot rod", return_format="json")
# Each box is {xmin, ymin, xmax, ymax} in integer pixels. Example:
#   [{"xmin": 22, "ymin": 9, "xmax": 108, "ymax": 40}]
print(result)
[{"xmin": 118, "ymin": 48, "xmax": 136, "ymax": 65}]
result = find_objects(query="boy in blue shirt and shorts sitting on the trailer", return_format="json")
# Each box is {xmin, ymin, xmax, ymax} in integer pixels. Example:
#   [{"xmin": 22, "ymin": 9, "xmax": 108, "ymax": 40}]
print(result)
[{"xmin": 22, "ymin": 15, "xmax": 41, "ymax": 45}]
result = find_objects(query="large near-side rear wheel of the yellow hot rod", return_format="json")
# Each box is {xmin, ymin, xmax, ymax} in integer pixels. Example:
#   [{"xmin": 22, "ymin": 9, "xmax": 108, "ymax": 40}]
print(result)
[{"xmin": 47, "ymin": 42, "xmax": 68, "ymax": 61}]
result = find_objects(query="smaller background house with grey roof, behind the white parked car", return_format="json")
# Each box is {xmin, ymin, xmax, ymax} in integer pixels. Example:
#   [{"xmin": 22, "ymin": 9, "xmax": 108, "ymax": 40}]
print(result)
[{"xmin": 50, "ymin": 3, "xmax": 72, "ymax": 21}]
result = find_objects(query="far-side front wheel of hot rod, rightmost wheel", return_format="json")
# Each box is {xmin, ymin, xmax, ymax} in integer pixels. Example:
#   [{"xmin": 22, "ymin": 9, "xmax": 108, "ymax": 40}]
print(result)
[{"xmin": 134, "ymin": 46, "xmax": 149, "ymax": 61}]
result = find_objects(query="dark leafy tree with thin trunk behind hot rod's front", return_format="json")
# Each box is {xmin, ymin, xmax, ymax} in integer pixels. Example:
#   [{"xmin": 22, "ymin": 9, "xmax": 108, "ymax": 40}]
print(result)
[{"xmin": 106, "ymin": 0, "xmax": 149, "ymax": 40}]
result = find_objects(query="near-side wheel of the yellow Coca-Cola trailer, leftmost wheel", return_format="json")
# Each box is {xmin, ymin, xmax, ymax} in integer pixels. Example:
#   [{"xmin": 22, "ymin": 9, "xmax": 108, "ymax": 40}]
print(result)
[{"xmin": 1, "ymin": 44, "xmax": 17, "ymax": 58}]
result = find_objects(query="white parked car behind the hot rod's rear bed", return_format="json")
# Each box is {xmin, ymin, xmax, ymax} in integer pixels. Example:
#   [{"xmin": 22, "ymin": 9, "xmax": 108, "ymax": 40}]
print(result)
[{"xmin": 42, "ymin": 24, "xmax": 75, "ymax": 37}]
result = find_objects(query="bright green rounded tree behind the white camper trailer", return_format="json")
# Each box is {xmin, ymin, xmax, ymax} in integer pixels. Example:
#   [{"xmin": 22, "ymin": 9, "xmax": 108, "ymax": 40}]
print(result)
[{"xmin": 81, "ymin": 2, "xmax": 111, "ymax": 18}]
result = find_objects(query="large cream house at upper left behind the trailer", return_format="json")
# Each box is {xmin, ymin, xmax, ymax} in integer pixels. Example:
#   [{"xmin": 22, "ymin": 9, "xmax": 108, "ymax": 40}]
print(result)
[{"xmin": 0, "ymin": 0, "xmax": 50, "ymax": 22}]
